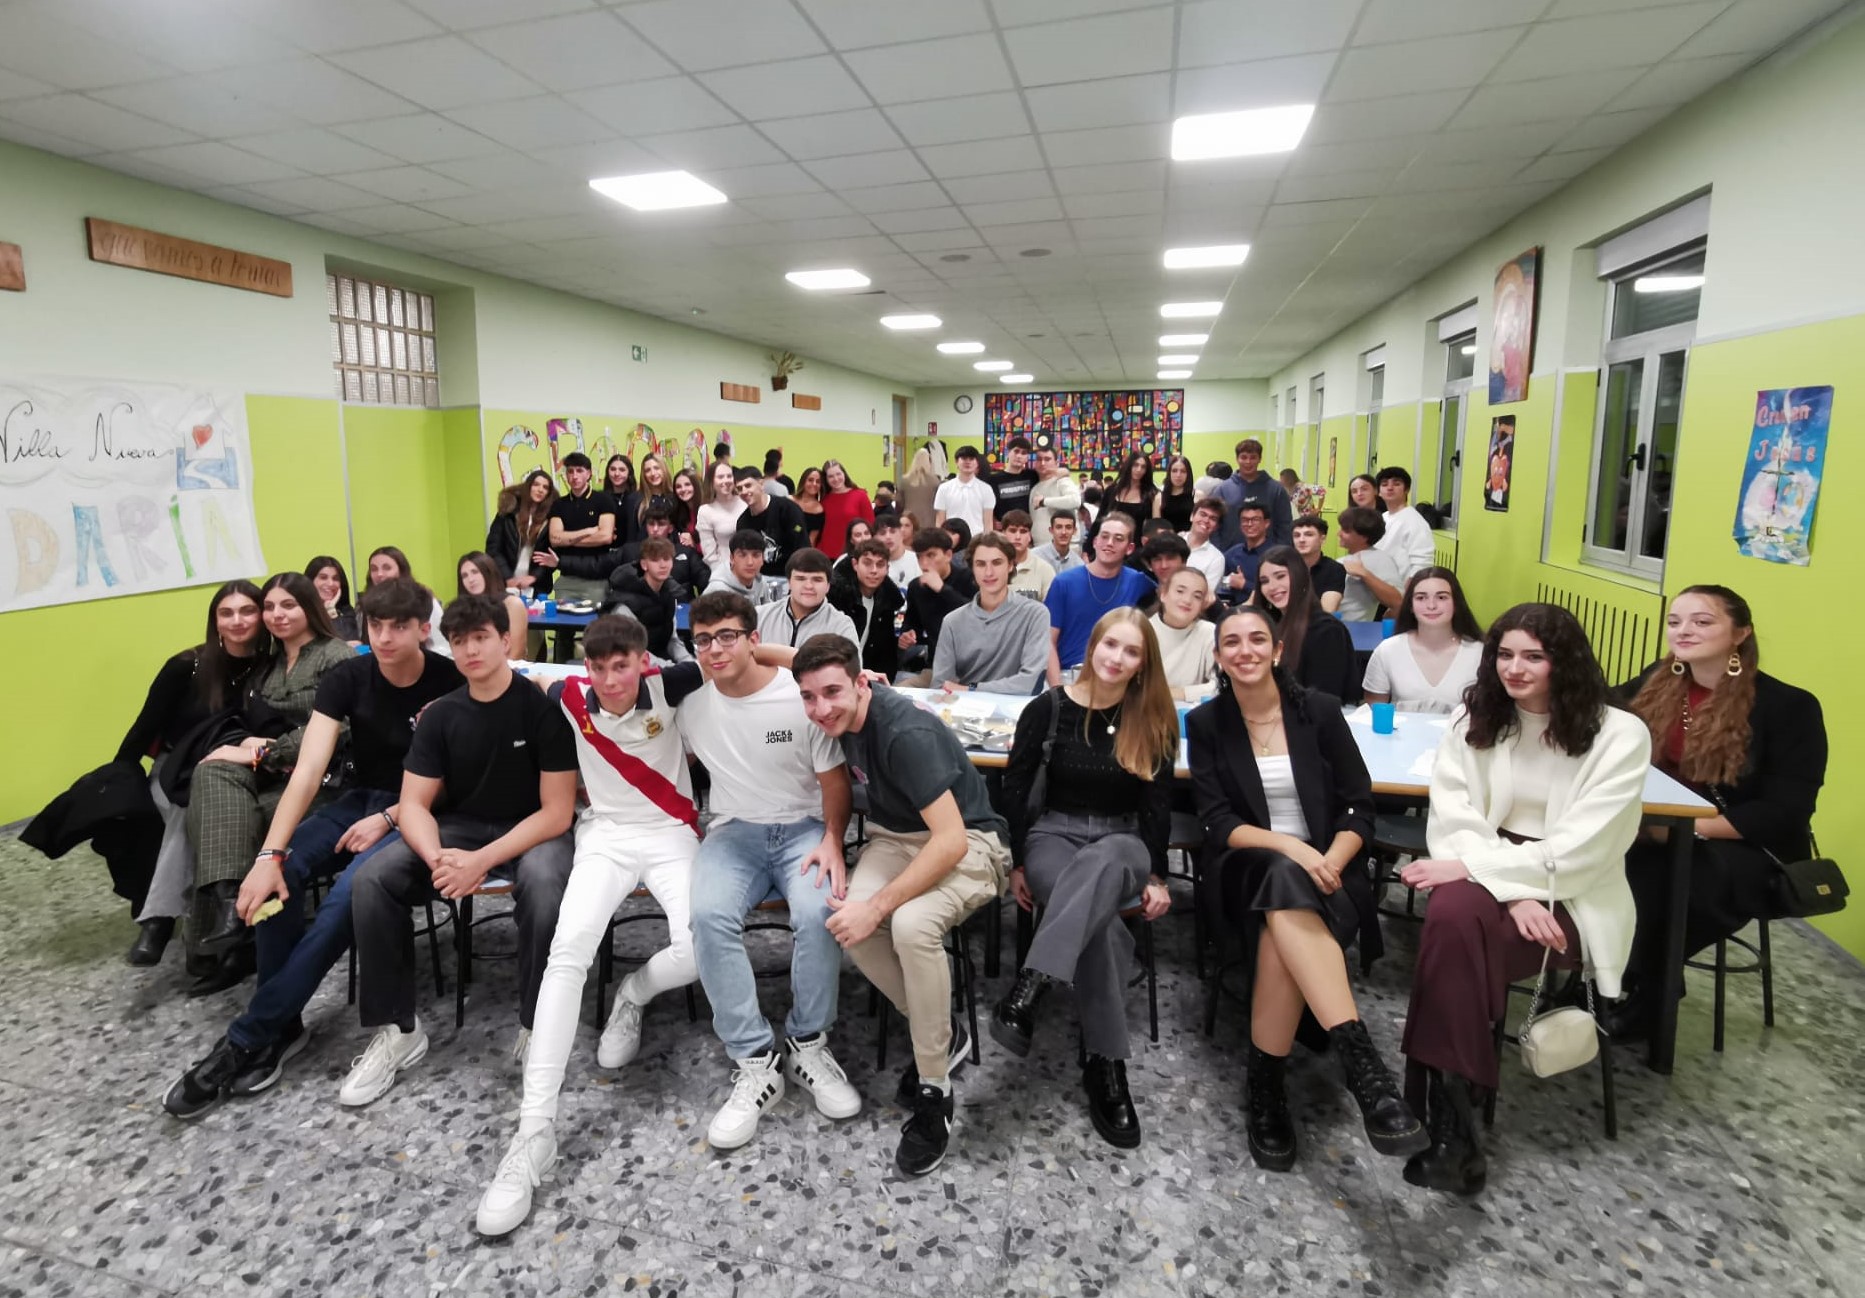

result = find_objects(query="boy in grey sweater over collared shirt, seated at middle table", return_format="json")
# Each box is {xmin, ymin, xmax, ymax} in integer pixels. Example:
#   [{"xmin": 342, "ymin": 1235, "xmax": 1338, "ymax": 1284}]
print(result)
[{"xmin": 933, "ymin": 533, "xmax": 1048, "ymax": 696}]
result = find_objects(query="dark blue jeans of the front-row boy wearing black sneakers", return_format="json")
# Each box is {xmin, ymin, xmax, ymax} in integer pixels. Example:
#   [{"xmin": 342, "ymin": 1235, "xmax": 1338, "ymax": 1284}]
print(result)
[{"xmin": 228, "ymin": 789, "xmax": 401, "ymax": 1050}]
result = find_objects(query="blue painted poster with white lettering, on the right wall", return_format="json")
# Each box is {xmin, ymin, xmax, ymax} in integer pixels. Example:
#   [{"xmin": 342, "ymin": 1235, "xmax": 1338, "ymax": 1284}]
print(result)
[{"xmin": 1734, "ymin": 388, "xmax": 1833, "ymax": 567}]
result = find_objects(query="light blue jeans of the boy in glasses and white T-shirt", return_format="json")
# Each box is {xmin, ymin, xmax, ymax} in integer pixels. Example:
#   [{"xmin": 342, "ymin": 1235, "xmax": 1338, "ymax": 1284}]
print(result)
[{"xmin": 692, "ymin": 817, "xmax": 841, "ymax": 1059}]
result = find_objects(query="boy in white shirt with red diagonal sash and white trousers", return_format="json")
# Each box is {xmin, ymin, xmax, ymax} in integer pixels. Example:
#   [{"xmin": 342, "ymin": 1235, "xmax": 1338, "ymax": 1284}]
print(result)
[{"xmin": 476, "ymin": 617, "xmax": 703, "ymax": 1235}]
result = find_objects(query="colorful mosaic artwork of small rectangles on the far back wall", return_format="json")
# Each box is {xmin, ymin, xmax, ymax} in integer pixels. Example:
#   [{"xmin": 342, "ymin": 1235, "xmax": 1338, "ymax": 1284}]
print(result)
[{"xmin": 985, "ymin": 388, "xmax": 1184, "ymax": 472}]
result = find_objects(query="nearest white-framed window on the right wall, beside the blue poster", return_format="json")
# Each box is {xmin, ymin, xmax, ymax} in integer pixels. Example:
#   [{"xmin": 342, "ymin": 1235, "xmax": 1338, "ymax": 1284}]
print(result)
[{"xmin": 1583, "ymin": 200, "xmax": 1708, "ymax": 576}]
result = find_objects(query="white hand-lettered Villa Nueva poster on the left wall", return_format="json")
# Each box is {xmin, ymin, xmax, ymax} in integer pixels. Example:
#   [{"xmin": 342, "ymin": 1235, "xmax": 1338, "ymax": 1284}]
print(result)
[{"xmin": 0, "ymin": 379, "xmax": 265, "ymax": 612}]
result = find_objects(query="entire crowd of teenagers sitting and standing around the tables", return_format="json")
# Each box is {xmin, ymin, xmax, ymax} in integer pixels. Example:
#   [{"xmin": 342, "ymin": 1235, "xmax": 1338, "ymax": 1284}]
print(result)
[{"xmin": 65, "ymin": 432, "xmax": 1826, "ymax": 1235}]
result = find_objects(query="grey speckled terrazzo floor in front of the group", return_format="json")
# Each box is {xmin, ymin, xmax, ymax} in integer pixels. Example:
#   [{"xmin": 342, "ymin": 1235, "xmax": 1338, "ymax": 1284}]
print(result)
[{"xmin": 0, "ymin": 835, "xmax": 1865, "ymax": 1298}]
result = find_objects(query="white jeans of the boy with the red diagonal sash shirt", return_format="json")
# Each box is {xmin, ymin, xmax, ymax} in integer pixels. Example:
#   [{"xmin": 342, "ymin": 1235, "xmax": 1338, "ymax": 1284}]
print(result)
[{"xmin": 518, "ymin": 815, "xmax": 699, "ymax": 1119}]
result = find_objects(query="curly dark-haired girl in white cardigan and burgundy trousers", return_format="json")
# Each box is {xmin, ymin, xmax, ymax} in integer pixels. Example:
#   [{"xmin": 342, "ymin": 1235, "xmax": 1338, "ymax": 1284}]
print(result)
[{"xmin": 1401, "ymin": 604, "xmax": 1651, "ymax": 1194}]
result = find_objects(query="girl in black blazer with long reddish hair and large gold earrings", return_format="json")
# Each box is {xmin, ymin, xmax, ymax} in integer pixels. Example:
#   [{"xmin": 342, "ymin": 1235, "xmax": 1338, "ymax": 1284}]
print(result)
[{"xmin": 1608, "ymin": 586, "xmax": 1826, "ymax": 1035}]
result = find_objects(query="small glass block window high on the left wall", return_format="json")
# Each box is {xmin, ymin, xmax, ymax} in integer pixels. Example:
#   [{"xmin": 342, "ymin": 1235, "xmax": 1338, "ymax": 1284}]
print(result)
[{"xmin": 325, "ymin": 274, "xmax": 440, "ymax": 407}]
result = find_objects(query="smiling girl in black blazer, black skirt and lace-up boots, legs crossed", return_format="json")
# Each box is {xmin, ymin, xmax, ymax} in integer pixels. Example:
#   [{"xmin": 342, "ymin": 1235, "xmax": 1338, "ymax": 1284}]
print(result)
[{"xmin": 1186, "ymin": 606, "xmax": 1430, "ymax": 1171}]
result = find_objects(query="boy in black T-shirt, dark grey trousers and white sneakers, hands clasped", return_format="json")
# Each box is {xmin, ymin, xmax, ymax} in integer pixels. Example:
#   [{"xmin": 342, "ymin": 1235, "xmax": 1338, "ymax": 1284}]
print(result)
[{"xmin": 338, "ymin": 595, "xmax": 576, "ymax": 1106}]
